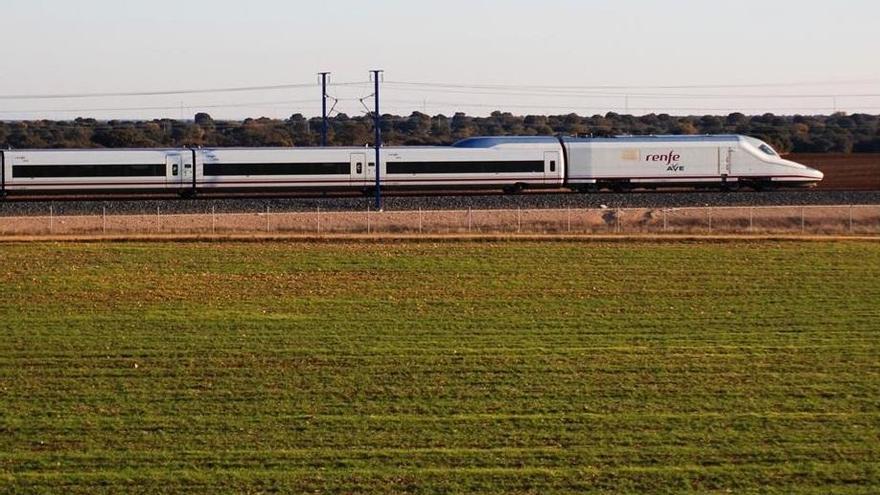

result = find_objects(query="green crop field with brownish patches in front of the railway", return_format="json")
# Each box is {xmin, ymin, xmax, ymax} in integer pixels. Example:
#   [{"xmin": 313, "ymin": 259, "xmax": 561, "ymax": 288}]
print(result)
[{"xmin": 0, "ymin": 241, "xmax": 880, "ymax": 494}]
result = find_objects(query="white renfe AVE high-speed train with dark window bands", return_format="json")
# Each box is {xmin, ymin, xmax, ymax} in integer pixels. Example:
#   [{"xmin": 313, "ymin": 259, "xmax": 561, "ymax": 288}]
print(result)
[{"xmin": 0, "ymin": 135, "xmax": 823, "ymax": 195}]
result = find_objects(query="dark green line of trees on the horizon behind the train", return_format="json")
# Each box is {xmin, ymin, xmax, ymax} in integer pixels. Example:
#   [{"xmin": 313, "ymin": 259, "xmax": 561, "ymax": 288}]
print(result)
[{"xmin": 0, "ymin": 112, "xmax": 880, "ymax": 153}]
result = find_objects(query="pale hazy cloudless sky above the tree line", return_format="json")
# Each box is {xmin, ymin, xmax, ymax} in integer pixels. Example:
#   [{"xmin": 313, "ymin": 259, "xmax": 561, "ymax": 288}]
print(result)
[{"xmin": 0, "ymin": 0, "xmax": 880, "ymax": 120}]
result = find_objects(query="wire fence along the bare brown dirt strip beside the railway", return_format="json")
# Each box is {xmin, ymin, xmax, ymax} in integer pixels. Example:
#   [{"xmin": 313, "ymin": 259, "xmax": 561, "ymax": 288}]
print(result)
[{"xmin": 0, "ymin": 205, "xmax": 880, "ymax": 236}]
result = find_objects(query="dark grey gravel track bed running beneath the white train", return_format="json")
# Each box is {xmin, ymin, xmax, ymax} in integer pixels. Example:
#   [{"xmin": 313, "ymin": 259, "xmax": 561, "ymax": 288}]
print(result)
[{"xmin": 0, "ymin": 190, "xmax": 880, "ymax": 216}]
